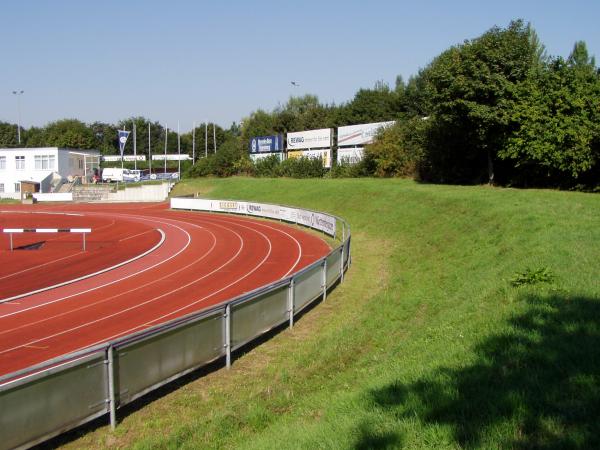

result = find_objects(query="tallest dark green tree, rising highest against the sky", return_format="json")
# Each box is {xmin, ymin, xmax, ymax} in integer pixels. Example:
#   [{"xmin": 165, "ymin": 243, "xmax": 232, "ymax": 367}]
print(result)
[{"xmin": 415, "ymin": 20, "xmax": 539, "ymax": 183}]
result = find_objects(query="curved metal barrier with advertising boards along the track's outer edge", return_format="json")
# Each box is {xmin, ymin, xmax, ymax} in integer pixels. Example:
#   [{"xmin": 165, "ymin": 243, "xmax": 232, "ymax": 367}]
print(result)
[{"xmin": 0, "ymin": 198, "xmax": 351, "ymax": 449}]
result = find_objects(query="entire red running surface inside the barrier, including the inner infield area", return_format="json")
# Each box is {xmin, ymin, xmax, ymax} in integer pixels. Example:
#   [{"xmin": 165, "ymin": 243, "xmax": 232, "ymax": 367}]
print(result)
[{"xmin": 0, "ymin": 204, "xmax": 329, "ymax": 375}]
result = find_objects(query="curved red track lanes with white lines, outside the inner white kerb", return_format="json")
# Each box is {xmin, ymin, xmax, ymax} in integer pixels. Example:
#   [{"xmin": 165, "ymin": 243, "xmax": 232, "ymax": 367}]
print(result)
[{"xmin": 0, "ymin": 205, "xmax": 329, "ymax": 375}]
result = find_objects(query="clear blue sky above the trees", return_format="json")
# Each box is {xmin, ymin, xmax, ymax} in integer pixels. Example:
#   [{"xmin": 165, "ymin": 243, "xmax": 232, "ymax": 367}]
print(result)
[{"xmin": 0, "ymin": 0, "xmax": 600, "ymax": 131}]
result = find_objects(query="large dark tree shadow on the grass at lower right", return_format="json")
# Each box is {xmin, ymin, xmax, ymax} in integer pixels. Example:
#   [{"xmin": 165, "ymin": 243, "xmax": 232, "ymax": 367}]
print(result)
[{"xmin": 357, "ymin": 295, "xmax": 600, "ymax": 449}]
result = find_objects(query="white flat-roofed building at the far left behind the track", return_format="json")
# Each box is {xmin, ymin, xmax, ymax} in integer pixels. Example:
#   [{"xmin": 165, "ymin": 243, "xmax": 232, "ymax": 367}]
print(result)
[{"xmin": 0, "ymin": 147, "xmax": 100, "ymax": 199}]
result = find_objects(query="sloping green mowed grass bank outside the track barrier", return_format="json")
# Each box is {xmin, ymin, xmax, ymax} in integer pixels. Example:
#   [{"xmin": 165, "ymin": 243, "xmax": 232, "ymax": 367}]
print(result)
[{"xmin": 66, "ymin": 178, "xmax": 600, "ymax": 449}]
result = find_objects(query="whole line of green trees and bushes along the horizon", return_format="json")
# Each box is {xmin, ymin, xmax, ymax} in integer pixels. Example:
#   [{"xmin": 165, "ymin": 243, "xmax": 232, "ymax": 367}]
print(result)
[{"xmin": 0, "ymin": 20, "xmax": 600, "ymax": 189}]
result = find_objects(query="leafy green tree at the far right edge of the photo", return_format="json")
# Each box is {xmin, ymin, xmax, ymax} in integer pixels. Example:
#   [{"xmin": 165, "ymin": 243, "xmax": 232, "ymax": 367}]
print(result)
[{"xmin": 499, "ymin": 56, "xmax": 600, "ymax": 185}]
